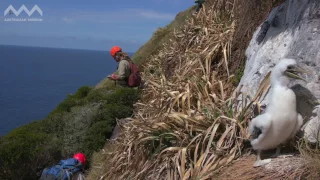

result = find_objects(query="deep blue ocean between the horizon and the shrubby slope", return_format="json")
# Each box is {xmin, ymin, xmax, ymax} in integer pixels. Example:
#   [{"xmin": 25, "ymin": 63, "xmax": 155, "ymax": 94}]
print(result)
[{"xmin": 0, "ymin": 45, "xmax": 117, "ymax": 136}]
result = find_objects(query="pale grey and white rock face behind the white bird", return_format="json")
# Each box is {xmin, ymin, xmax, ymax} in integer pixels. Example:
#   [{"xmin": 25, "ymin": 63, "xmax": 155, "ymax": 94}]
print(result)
[{"xmin": 239, "ymin": 0, "xmax": 320, "ymax": 142}]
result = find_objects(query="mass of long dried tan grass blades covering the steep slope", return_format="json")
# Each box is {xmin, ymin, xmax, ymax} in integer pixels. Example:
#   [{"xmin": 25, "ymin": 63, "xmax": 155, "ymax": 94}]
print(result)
[{"xmin": 101, "ymin": 0, "xmax": 268, "ymax": 179}]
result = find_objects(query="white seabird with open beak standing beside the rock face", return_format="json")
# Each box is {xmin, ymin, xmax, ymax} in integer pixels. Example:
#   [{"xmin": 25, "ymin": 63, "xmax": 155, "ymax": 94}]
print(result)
[{"xmin": 249, "ymin": 59, "xmax": 306, "ymax": 167}]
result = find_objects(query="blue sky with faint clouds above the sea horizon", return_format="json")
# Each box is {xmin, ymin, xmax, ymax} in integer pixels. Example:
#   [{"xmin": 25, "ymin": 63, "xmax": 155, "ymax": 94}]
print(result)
[{"xmin": 0, "ymin": 0, "xmax": 194, "ymax": 52}]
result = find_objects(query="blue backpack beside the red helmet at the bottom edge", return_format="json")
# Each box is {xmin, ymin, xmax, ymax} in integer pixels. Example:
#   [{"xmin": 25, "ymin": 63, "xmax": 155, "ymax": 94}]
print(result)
[{"xmin": 39, "ymin": 158, "xmax": 83, "ymax": 180}]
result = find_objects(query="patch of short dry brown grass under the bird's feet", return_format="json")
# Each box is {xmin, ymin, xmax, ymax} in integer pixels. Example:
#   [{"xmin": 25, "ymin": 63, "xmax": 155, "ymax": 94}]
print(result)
[{"xmin": 214, "ymin": 139, "xmax": 320, "ymax": 180}]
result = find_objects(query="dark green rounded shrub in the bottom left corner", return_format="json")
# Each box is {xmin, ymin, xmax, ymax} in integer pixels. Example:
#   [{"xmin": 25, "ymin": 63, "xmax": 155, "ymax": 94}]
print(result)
[{"xmin": 0, "ymin": 122, "xmax": 60, "ymax": 179}]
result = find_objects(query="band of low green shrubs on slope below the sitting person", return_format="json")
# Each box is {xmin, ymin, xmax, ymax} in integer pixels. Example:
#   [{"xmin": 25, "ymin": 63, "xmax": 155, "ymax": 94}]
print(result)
[{"xmin": 0, "ymin": 86, "xmax": 139, "ymax": 179}]
